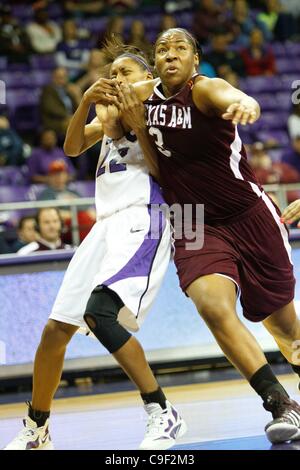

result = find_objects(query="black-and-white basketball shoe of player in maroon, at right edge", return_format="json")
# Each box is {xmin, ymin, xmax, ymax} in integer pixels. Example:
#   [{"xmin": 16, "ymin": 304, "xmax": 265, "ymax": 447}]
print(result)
[{"xmin": 263, "ymin": 392, "xmax": 300, "ymax": 444}]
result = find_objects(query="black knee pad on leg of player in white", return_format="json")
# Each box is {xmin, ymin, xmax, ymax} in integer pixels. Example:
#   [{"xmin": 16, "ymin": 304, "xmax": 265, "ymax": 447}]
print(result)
[{"xmin": 83, "ymin": 286, "xmax": 131, "ymax": 353}]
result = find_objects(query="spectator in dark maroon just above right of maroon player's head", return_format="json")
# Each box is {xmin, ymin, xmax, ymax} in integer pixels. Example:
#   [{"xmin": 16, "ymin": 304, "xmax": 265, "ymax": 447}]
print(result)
[{"xmin": 192, "ymin": 0, "xmax": 224, "ymax": 44}]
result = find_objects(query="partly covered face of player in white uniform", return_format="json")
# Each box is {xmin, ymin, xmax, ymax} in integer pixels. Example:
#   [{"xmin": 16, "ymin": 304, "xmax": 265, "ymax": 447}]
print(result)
[{"xmin": 110, "ymin": 57, "xmax": 152, "ymax": 84}]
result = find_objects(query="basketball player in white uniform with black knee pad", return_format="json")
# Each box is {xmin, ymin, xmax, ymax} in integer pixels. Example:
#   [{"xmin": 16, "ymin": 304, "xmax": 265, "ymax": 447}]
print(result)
[{"xmin": 6, "ymin": 43, "xmax": 186, "ymax": 450}]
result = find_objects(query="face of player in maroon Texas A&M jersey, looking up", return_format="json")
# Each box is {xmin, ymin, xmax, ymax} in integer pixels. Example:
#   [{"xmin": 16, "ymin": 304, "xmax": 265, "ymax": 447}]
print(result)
[{"xmin": 155, "ymin": 31, "xmax": 199, "ymax": 94}]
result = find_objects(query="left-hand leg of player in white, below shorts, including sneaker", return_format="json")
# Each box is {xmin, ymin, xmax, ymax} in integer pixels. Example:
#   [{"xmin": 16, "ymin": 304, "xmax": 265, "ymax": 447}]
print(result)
[{"xmin": 5, "ymin": 319, "xmax": 78, "ymax": 450}]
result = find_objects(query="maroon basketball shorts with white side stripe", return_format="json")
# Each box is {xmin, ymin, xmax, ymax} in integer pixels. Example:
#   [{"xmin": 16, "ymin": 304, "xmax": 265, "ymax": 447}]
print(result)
[{"xmin": 175, "ymin": 194, "xmax": 295, "ymax": 322}]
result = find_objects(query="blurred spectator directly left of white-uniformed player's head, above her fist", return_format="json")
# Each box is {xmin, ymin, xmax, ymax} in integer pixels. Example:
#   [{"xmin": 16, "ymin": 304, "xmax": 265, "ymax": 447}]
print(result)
[{"xmin": 75, "ymin": 49, "xmax": 106, "ymax": 93}]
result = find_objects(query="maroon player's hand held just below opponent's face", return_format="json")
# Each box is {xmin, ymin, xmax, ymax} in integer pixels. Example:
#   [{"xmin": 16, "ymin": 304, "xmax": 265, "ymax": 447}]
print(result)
[{"xmin": 117, "ymin": 84, "xmax": 146, "ymax": 132}]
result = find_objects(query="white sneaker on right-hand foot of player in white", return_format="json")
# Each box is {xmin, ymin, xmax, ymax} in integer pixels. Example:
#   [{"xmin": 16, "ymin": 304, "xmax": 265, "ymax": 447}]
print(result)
[{"xmin": 139, "ymin": 401, "xmax": 187, "ymax": 450}]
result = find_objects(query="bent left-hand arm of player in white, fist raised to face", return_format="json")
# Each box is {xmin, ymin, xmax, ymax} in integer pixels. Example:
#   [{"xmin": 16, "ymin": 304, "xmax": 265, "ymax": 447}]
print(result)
[{"xmin": 64, "ymin": 78, "xmax": 117, "ymax": 157}]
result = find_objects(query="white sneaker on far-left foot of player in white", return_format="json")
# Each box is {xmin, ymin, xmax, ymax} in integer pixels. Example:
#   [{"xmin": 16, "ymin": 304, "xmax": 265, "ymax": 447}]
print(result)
[{"xmin": 4, "ymin": 416, "xmax": 54, "ymax": 450}]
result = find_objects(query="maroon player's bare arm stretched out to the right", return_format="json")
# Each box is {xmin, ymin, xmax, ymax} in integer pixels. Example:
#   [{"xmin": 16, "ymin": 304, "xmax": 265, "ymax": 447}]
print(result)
[{"xmin": 193, "ymin": 77, "xmax": 260, "ymax": 125}]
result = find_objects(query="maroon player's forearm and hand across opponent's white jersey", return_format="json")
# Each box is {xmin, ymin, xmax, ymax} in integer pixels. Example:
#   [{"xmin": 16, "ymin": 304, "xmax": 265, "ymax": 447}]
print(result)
[{"xmin": 117, "ymin": 82, "xmax": 159, "ymax": 181}]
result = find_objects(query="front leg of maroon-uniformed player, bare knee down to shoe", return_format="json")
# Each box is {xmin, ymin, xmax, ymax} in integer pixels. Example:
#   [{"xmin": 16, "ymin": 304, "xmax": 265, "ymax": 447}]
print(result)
[{"xmin": 187, "ymin": 275, "xmax": 300, "ymax": 443}]
